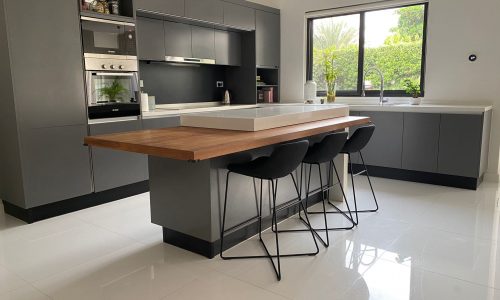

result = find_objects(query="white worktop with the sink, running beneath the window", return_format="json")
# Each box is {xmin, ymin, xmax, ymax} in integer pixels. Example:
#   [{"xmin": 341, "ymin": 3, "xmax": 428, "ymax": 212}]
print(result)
[{"xmin": 349, "ymin": 104, "xmax": 493, "ymax": 114}]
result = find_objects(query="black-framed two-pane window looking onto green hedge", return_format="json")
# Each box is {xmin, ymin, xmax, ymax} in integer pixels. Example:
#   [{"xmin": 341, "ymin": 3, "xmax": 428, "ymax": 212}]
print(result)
[{"xmin": 307, "ymin": 4, "xmax": 427, "ymax": 96}]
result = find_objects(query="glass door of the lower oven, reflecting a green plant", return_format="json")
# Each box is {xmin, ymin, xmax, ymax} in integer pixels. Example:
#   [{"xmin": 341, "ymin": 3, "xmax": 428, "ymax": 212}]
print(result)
[{"xmin": 87, "ymin": 72, "xmax": 138, "ymax": 106}]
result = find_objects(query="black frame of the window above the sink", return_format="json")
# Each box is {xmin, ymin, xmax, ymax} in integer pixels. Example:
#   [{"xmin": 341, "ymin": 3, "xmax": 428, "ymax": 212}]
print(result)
[{"xmin": 306, "ymin": 2, "xmax": 429, "ymax": 97}]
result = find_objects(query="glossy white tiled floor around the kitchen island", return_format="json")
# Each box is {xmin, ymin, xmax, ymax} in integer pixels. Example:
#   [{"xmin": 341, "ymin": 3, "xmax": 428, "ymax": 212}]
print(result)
[{"xmin": 0, "ymin": 178, "xmax": 500, "ymax": 300}]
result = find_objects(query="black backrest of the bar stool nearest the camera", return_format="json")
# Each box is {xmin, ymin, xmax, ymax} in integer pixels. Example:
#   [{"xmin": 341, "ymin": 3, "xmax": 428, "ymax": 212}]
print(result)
[{"xmin": 265, "ymin": 140, "xmax": 309, "ymax": 179}]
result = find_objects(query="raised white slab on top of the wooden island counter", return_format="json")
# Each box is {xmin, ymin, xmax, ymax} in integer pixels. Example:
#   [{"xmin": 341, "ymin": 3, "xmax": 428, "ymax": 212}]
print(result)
[{"xmin": 181, "ymin": 104, "xmax": 349, "ymax": 131}]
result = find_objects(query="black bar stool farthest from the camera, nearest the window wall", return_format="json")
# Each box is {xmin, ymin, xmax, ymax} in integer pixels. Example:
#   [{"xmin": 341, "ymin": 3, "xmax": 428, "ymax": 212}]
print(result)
[{"xmin": 340, "ymin": 124, "xmax": 379, "ymax": 225}]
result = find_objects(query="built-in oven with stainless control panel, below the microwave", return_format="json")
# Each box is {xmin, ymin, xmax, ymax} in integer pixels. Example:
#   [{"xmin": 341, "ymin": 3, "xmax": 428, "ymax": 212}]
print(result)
[{"xmin": 85, "ymin": 54, "xmax": 141, "ymax": 120}]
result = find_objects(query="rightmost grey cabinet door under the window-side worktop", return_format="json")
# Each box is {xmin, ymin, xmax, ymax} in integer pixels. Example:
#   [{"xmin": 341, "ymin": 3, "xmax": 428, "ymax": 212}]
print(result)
[{"xmin": 438, "ymin": 114, "xmax": 483, "ymax": 178}]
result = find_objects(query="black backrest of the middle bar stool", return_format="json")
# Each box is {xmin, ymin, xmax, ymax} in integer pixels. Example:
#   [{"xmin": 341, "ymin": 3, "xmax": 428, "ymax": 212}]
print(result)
[{"xmin": 304, "ymin": 132, "xmax": 348, "ymax": 163}]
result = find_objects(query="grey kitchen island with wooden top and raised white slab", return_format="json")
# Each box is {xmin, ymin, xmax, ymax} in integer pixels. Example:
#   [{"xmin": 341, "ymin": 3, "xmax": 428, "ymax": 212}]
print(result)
[{"xmin": 85, "ymin": 105, "xmax": 370, "ymax": 258}]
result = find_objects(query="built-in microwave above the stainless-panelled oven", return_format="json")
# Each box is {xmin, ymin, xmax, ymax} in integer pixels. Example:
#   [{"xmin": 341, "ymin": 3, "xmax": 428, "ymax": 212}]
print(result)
[{"xmin": 81, "ymin": 17, "xmax": 137, "ymax": 56}]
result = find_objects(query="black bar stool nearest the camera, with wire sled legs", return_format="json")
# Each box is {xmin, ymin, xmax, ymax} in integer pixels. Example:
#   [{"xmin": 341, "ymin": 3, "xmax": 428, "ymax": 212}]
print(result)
[{"xmin": 220, "ymin": 141, "xmax": 319, "ymax": 280}]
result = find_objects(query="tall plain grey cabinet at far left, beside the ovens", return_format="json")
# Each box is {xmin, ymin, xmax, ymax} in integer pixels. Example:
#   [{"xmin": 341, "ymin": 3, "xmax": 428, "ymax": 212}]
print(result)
[{"xmin": 0, "ymin": 0, "xmax": 92, "ymax": 209}]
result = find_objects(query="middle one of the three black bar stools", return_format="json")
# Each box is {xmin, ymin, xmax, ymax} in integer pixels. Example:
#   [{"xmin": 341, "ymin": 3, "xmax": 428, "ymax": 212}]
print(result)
[{"xmin": 279, "ymin": 132, "xmax": 355, "ymax": 247}]
